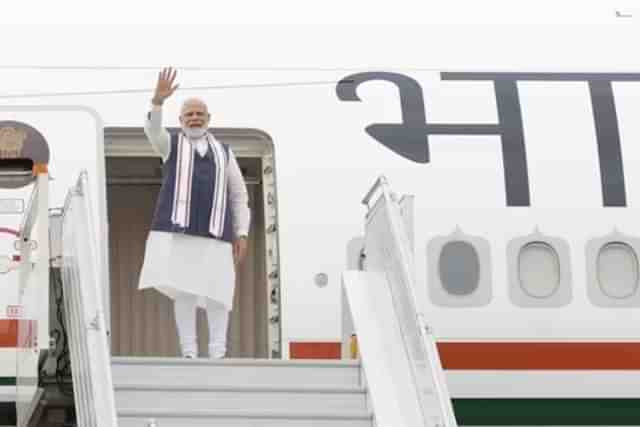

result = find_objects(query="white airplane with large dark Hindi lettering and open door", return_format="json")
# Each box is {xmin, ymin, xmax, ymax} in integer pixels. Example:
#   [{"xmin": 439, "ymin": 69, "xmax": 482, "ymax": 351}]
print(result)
[{"xmin": 0, "ymin": 21, "xmax": 640, "ymax": 425}]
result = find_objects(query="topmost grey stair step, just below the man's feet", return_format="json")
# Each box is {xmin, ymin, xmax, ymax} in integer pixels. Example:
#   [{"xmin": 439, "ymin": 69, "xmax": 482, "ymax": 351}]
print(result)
[{"xmin": 112, "ymin": 357, "xmax": 361, "ymax": 387}]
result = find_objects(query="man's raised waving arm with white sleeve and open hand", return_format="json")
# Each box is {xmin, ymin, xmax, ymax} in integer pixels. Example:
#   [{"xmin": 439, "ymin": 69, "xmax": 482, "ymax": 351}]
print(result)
[{"xmin": 144, "ymin": 68, "xmax": 178, "ymax": 161}]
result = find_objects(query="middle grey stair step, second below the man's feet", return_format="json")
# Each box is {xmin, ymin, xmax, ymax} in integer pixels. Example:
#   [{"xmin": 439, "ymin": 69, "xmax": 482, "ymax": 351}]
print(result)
[{"xmin": 115, "ymin": 385, "xmax": 366, "ymax": 414}]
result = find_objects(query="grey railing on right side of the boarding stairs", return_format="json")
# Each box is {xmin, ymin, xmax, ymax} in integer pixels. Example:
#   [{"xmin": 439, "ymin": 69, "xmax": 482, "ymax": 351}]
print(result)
[{"xmin": 362, "ymin": 176, "xmax": 457, "ymax": 427}]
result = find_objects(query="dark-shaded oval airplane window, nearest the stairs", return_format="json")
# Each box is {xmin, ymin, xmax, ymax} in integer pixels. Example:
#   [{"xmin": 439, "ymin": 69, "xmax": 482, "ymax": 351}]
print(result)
[{"xmin": 438, "ymin": 240, "xmax": 480, "ymax": 296}]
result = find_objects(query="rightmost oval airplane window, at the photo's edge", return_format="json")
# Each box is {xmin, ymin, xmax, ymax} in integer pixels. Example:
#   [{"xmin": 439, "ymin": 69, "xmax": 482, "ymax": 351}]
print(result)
[{"xmin": 597, "ymin": 242, "xmax": 638, "ymax": 299}]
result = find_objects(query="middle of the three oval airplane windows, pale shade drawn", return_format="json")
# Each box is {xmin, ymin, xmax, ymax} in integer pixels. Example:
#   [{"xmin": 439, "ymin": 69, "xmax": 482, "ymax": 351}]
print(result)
[{"xmin": 518, "ymin": 242, "xmax": 560, "ymax": 298}]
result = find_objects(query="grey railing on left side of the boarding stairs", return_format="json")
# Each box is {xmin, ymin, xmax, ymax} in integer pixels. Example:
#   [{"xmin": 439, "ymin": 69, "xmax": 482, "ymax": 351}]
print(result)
[{"xmin": 61, "ymin": 171, "xmax": 117, "ymax": 427}]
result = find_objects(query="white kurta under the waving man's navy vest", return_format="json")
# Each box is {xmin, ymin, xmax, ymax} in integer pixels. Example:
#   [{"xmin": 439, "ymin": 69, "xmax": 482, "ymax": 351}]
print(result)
[{"xmin": 138, "ymin": 107, "xmax": 250, "ymax": 310}]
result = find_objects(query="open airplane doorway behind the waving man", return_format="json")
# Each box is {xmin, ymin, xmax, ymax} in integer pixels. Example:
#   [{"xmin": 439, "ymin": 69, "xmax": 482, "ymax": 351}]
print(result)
[{"xmin": 105, "ymin": 128, "xmax": 280, "ymax": 358}]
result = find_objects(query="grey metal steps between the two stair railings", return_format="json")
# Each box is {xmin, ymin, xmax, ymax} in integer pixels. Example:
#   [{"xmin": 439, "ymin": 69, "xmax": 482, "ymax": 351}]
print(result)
[{"xmin": 112, "ymin": 357, "xmax": 373, "ymax": 427}]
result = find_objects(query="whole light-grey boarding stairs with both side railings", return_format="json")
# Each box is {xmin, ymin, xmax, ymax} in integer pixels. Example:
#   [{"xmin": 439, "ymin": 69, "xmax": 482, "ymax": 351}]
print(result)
[{"xmin": 19, "ymin": 163, "xmax": 456, "ymax": 427}]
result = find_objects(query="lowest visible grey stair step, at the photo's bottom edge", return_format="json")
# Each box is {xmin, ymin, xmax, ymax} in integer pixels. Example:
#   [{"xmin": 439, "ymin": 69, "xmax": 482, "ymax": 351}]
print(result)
[{"xmin": 118, "ymin": 410, "xmax": 373, "ymax": 427}]
